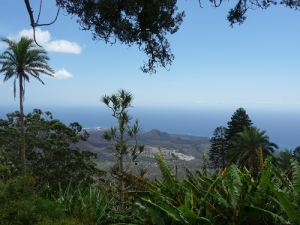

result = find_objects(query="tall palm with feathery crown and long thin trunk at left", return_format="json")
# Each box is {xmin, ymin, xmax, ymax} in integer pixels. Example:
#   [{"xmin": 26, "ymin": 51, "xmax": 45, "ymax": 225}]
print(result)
[{"xmin": 0, "ymin": 37, "xmax": 54, "ymax": 176}]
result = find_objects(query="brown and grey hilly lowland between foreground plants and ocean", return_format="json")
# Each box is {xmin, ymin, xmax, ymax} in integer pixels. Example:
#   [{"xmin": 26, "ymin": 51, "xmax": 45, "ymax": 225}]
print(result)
[{"xmin": 72, "ymin": 128, "xmax": 210, "ymax": 177}]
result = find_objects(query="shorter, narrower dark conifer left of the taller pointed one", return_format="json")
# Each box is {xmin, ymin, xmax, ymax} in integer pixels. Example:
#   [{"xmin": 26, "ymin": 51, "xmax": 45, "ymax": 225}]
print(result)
[{"xmin": 208, "ymin": 126, "xmax": 227, "ymax": 170}]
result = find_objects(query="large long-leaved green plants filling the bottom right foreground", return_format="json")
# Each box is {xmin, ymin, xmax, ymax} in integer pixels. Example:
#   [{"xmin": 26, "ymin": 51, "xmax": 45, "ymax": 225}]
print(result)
[{"xmin": 123, "ymin": 144, "xmax": 300, "ymax": 225}]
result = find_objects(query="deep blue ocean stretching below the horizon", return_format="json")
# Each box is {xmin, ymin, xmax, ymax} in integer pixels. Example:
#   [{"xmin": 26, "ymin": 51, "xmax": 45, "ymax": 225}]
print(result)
[{"xmin": 0, "ymin": 104, "xmax": 300, "ymax": 150}]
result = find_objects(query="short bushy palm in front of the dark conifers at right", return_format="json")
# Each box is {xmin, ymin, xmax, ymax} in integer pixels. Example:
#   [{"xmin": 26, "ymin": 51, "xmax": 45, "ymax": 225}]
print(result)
[{"xmin": 226, "ymin": 127, "xmax": 278, "ymax": 172}]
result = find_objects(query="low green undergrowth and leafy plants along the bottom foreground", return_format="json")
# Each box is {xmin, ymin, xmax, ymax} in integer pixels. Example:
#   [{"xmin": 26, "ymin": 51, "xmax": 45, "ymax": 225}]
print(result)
[{"xmin": 0, "ymin": 124, "xmax": 300, "ymax": 224}]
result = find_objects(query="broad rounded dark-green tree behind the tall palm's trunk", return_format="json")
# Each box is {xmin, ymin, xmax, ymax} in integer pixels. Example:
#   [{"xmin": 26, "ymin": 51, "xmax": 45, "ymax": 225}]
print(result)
[{"xmin": 0, "ymin": 109, "xmax": 105, "ymax": 194}]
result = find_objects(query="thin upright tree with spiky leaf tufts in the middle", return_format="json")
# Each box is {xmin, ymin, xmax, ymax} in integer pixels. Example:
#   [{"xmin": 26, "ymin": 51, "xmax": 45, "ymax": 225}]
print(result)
[{"xmin": 101, "ymin": 89, "xmax": 144, "ymax": 215}]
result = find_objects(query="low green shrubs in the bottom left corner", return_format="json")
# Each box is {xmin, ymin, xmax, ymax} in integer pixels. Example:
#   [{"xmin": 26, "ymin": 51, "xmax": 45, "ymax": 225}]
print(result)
[{"xmin": 0, "ymin": 176, "xmax": 65, "ymax": 224}]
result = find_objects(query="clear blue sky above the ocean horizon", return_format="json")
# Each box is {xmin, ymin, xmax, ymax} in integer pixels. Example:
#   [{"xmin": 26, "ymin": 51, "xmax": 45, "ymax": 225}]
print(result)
[{"xmin": 0, "ymin": 0, "xmax": 300, "ymax": 111}]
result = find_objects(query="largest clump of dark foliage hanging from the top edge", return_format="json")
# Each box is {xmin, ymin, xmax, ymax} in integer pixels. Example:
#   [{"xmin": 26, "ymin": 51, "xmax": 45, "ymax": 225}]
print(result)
[{"xmin": 56, "ymin": 0, "xmax": 185, "ymax": 73}]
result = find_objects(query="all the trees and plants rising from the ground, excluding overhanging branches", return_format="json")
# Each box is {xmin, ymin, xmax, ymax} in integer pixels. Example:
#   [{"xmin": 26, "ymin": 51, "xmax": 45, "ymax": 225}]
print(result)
[{"xmin": 0, "ymin": 38, "xmax": 300, "ymax": 225}]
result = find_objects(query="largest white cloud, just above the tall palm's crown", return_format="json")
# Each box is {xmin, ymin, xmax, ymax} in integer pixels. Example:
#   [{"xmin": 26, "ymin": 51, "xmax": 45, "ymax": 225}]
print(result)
[{"xmin": 8, "ymin": 28, "xmax": 82, "ymax": 54}]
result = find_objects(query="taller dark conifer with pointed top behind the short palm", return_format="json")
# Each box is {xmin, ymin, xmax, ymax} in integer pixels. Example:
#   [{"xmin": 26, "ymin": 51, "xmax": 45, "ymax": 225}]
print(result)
[{"xmin": 226, "ymin": 108, "xmax": 253, "ymax": 141}]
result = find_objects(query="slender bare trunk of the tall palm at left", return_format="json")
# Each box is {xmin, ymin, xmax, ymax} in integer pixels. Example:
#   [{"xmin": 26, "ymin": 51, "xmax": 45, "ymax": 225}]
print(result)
[{"xmin": 19, "ymin": 75, "xmax": 26, "ymax": 177}]
